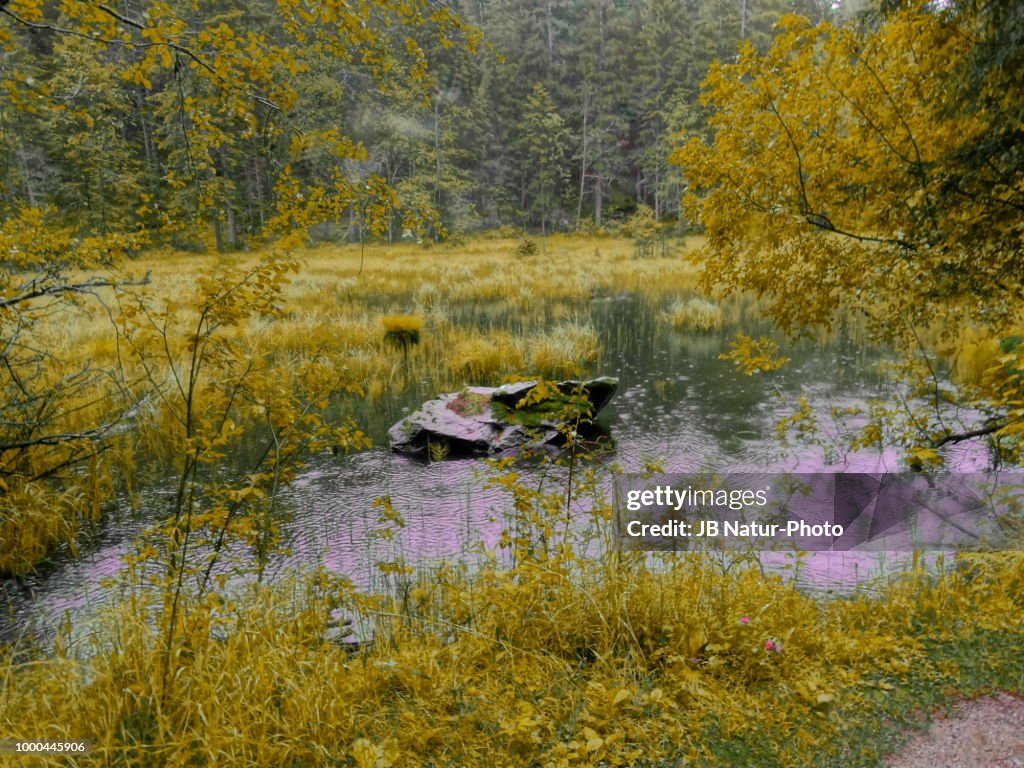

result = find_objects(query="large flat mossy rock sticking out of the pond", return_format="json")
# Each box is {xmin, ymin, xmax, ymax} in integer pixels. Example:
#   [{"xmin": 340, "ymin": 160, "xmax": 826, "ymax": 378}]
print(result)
[{"xmin": 388, "ymin": 377, "xmax": 618, "ymax": 455}]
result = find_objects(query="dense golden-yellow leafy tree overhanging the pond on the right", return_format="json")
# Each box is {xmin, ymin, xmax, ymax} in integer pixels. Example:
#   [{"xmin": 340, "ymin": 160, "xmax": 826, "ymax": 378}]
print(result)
[{"xmin": 672, "ymin": 2, "xmax": 1024, "ymax": 460}]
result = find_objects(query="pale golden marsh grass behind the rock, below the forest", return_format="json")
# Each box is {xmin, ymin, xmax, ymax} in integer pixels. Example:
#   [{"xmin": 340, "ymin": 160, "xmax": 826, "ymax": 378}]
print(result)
[{"xmin": 229, "ymin": 236, "xmax": 695, "ymax": 399}]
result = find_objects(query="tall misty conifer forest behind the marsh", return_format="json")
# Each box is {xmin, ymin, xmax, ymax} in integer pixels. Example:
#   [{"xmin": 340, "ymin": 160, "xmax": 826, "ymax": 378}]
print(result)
[{"xmin": 0, "ymin": 0, "xmax": 854, "ymax": 251}]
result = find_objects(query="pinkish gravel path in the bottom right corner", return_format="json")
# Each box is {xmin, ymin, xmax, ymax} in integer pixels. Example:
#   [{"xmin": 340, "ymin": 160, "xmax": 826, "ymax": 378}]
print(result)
[{"xmin": 886, "ymin": 693, "xmax": 1024, "ymax": 768}]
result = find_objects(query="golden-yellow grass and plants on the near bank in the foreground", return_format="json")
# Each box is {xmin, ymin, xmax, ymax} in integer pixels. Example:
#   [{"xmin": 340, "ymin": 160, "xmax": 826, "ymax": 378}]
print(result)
[{"xmin": 0, "ymin": 553, "xmax": 1024, "ymax": 768}]
